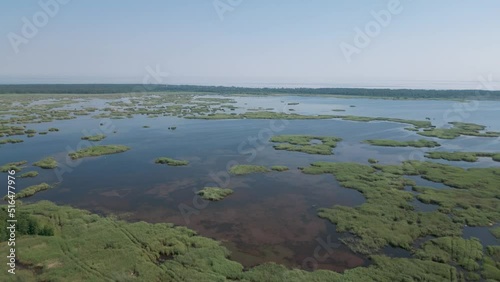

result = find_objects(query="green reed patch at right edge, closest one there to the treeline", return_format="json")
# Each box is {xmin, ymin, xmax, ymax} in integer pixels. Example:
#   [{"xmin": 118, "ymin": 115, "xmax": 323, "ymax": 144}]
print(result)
[{"xmin": 418, "ymin": 122, "xmax": 500, "ymax": 139}]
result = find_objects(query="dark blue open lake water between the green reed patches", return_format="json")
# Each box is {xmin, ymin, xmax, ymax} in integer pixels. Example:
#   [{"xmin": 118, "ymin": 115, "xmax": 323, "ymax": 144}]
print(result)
[{"xmin": 0, "ymin": 96, "xmax": 500, "ymax": 271}]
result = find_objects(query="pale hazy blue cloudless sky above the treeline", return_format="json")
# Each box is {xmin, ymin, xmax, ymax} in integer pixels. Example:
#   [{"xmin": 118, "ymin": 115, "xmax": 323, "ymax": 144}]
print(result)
[{"xmin": 0, "ymin": 0, "xmax": 500, "ymax": 88}]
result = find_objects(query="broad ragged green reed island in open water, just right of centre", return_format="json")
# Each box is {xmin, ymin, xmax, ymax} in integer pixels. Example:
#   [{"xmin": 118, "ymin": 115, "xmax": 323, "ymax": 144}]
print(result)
[{"xmin": 269, "ymin": 135, "xmax": 342, "ymax": 155}]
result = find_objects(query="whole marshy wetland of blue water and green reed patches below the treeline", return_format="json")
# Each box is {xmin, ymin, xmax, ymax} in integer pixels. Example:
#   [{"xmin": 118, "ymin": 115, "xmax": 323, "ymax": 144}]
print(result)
[{"xmin": 0, "ymin": 93, "xmax": 500, "ymax": 281}]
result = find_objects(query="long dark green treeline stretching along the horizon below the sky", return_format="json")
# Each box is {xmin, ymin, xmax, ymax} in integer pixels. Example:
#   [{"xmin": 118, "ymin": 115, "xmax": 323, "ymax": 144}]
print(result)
[{"xmin": 0, "ymin": 84, "xmax": 500, "ymax": 100}]
